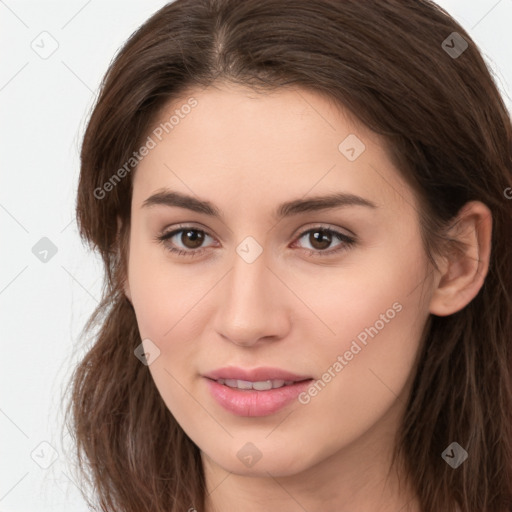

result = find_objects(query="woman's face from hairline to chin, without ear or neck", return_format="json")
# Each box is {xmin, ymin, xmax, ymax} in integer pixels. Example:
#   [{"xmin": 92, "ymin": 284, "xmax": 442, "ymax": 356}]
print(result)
[{"xmin": 126, "ymin": 85, "xmax": 432, "ymax": 476}]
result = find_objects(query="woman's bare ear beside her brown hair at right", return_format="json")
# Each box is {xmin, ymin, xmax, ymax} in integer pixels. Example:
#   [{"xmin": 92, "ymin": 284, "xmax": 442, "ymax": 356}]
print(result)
[{"xmin": 430, "ymin": 201, "xmax": 492, "ymax": 316}]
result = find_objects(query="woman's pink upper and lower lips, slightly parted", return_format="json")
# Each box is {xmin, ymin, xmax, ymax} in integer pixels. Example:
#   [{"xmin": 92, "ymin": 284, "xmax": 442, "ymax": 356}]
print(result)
[{"xmin": 203, "ymin": 367, "xmax": 313, "ymax": 417}]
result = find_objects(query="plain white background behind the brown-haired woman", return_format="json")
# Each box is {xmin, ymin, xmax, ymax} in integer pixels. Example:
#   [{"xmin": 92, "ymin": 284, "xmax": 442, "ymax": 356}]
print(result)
[{"xmin": 0, "ymin": 0, "xmax": 512, "ymax": 512}]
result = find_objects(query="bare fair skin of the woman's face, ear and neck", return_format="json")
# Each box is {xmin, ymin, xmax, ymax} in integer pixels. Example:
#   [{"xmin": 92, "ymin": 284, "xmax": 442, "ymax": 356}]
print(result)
[{"xmin": 121, "ymin": 84, "xmax": 491, "ymax": 512}]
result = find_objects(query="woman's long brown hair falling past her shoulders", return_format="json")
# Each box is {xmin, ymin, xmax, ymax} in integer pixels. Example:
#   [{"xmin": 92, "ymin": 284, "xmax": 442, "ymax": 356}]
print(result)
[{"xmin": 67, "ymin": 0, "xmax": 512, "ymax": 512}]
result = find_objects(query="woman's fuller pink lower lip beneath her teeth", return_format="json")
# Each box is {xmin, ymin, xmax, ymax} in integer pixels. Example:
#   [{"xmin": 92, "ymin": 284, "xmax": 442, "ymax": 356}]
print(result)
[{"xmin": 206, "ymin": 378, "xmax": 312, "ymax": 416}]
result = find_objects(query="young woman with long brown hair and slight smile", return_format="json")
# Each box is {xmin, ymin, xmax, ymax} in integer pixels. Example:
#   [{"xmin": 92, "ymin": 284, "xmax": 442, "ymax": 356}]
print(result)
[{"xmin": 65, "ymin": 0, "xmax": 512, "ymax": 512}]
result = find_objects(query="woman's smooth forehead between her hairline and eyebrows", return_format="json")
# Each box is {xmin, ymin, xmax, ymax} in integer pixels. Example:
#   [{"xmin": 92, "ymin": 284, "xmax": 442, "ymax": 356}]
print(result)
[{"xmin": 133, "ymin": 84, "xmax": 414, "ymax": 216}]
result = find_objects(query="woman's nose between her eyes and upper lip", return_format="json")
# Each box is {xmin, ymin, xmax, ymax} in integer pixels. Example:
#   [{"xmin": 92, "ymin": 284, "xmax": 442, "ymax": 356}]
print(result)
[{"xmin": 215, "ymin": 248, "xmax": 292, "ymax": 347}]
